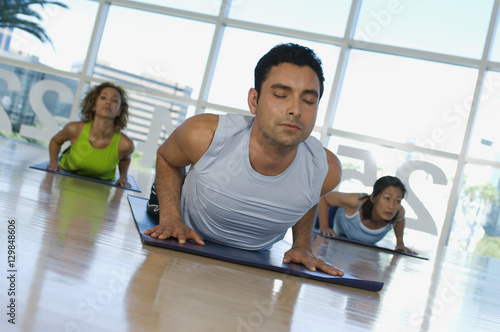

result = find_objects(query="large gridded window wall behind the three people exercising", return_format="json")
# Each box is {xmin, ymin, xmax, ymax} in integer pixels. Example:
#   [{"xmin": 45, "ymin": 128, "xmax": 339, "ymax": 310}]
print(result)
[{"xmin": 0, "ymin": 0, "xmax": 500, "ymax": 254}]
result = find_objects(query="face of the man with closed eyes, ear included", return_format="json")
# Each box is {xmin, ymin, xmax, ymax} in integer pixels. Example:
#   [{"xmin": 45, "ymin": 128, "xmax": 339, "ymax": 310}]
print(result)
[{"xmin": 248, "ymin": 63, "xmax": 320, "ymax": 147}]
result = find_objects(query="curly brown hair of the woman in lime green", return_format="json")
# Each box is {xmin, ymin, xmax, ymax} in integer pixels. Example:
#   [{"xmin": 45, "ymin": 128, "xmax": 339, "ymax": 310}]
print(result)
[{"xmin": 80, "ymin": 82, "xmax": 128, "ymax": 132}]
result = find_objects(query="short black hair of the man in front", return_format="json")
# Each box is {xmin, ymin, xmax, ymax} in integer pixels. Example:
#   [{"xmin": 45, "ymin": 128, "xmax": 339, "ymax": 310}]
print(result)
[{"xmin": 254, "ymin": 43, "xmax": 325, "ymax": 99}]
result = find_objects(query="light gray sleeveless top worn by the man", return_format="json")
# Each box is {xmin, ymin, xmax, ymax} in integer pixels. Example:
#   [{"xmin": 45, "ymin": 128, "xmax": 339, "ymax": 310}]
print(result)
[{"xmin": 181, "ymin": 114, "xmax": 328, "ymax": 250}]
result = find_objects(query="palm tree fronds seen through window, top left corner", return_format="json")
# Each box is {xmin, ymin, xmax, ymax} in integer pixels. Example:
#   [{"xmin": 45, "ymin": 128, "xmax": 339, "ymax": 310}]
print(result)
[{"xmin": 0, "ymin": 0, "xmax": 68, "ymax": 43}]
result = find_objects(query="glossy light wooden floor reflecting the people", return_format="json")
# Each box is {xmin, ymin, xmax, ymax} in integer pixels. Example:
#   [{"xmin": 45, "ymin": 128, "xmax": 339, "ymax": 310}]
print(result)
[{"xmin": 0, "ymin": 137, "xmax": 500, "ymax": 332}]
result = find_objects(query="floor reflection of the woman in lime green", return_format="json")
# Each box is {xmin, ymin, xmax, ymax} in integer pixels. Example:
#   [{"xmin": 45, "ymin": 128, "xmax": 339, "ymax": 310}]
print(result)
[{"xmin": 19, "ymin": 173, "xmax": 123, "ymax": 331}]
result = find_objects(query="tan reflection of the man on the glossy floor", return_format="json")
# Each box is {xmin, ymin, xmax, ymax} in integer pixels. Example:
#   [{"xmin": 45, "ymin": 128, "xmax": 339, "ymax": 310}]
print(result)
[{"xmin": 127, "ymin": 248, "xmax": 301, "ymax": 331}]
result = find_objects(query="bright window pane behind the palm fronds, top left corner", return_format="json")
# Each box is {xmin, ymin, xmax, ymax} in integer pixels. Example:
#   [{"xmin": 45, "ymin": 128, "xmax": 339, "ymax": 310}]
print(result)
[{"xmin": 0, "ymin": 0, "xmax": 98, "ymax": 71}]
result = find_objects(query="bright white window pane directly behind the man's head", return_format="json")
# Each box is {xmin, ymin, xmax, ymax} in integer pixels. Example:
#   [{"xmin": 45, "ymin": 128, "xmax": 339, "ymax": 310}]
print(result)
[{"xmin": 208, "ymin": 28, "xmax": 340, "ymax": 125}]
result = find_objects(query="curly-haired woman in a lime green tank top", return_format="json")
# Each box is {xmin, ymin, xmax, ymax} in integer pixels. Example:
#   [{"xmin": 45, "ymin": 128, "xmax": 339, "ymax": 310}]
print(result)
[{"xmin": 47, "ymin": 82, "xmax": 134, "ymax": 187}]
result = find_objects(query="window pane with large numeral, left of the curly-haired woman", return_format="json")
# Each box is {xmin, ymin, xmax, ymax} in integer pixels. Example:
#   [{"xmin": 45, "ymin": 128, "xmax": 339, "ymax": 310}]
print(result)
[{"xmin": 0, "ymin": 64, "xmax": 78, "ymax": 143}]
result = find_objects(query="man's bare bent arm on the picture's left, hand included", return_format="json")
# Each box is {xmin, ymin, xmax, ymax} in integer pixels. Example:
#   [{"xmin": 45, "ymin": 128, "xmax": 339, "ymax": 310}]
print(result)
[{"xmin": 144, "ymin": 114, "xmax": 219, "ymax": 245}]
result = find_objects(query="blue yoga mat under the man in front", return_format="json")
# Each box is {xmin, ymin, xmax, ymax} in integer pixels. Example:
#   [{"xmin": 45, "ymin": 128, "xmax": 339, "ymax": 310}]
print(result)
[{"xmin": 128, "ymin": 195, "xmax": 384, "ymax": 292}]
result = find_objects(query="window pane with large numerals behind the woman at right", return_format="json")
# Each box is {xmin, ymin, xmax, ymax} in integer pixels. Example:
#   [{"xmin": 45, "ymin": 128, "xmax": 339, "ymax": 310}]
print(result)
[{"xmin": 327, "ymin": 137, "xmax": 456, "ymax": 252}]
